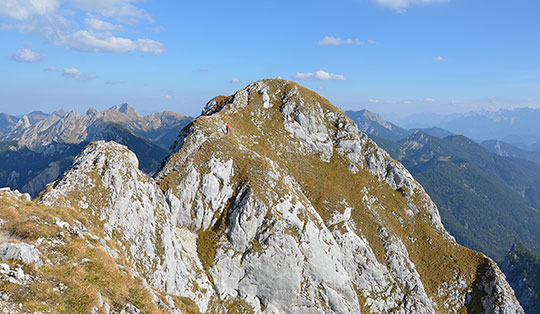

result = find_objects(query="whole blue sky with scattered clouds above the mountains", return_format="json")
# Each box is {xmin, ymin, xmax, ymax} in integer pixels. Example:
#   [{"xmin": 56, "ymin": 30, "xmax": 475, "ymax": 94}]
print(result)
[{"xmin": 0, "ymin": 0, "xmax": 540, "ymax": 115}]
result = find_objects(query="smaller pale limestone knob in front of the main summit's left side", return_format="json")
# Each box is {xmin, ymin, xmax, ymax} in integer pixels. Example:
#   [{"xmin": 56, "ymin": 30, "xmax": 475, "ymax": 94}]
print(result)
[{"xmin": 40, "ymin": 141, "xmax": 212, "ymax": 309}]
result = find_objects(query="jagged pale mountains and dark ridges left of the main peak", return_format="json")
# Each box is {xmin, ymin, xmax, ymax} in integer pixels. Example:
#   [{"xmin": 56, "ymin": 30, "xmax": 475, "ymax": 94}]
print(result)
[{"xmin": 0, "ymin": 104, "xmax": 191, "ymax": 196}]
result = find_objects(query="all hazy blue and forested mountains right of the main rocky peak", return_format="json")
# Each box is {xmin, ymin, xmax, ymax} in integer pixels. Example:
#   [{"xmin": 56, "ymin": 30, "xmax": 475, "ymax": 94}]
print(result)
[{"xmin": 351, "ymin": 110, "xmax": 540, "ymax": 314}]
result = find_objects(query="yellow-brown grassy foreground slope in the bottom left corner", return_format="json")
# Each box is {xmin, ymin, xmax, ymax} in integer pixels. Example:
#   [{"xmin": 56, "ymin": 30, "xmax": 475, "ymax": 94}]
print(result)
[{"xmin": 0, "ymin": 196, "xmax": 198, "ymax": 313}]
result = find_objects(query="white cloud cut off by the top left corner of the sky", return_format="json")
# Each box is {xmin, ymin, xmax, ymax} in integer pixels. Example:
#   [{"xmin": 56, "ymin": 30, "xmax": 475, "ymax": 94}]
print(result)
[{"xmin": 0, "ymin": 0, "xmax": 60, "ymax": 20}]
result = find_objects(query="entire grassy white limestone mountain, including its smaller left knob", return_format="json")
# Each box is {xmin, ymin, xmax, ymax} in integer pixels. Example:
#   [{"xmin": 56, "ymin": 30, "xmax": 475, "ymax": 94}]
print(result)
[{"xmin": 41, "ymin": 79, "xmax": 522, "ymax": 313}]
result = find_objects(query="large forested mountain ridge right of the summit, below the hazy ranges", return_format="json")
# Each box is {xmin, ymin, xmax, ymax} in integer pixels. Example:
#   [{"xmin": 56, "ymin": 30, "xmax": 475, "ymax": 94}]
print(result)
[{"xmin": 375, "ymin": 131, "xmax": 540, "ymax": 261}]
